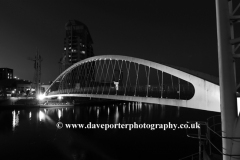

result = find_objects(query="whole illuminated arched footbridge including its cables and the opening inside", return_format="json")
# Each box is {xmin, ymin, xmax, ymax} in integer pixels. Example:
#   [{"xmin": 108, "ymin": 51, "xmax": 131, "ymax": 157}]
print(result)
[{"xmin": 44, "ymin": 55, "xmax": 220, "ymax": 112}]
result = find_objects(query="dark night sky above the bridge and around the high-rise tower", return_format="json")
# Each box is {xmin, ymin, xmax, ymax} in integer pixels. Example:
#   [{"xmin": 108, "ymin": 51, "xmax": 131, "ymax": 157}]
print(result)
[{"xmin": 0, "ymin": 0, "xmax": 218, "ymax": 83}]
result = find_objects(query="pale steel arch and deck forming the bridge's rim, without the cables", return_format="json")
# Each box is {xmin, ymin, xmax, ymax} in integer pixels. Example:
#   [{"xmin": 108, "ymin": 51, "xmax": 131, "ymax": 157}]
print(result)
[{"xmin": 45, "ymin": 55, "xmax": 220, "ymax": 112}]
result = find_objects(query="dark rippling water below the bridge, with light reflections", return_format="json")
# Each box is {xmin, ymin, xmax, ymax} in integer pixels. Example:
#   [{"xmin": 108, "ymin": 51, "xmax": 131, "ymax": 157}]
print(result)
[{"xmin": 0, "ymin": 102, "xmax": 219, "ymax": 160}]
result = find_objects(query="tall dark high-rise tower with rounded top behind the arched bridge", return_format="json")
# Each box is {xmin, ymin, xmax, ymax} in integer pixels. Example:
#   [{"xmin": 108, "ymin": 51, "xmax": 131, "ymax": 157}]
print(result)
[{"xmin": 60, "ymin": 20, "xmax": 94, "ymax": 72}]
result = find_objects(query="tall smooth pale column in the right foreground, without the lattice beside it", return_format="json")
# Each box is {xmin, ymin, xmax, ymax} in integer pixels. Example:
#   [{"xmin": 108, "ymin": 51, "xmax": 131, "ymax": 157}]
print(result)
[{"xmin": 216, "ymin": 0, "xmax": 240, "ymax": 160}]
